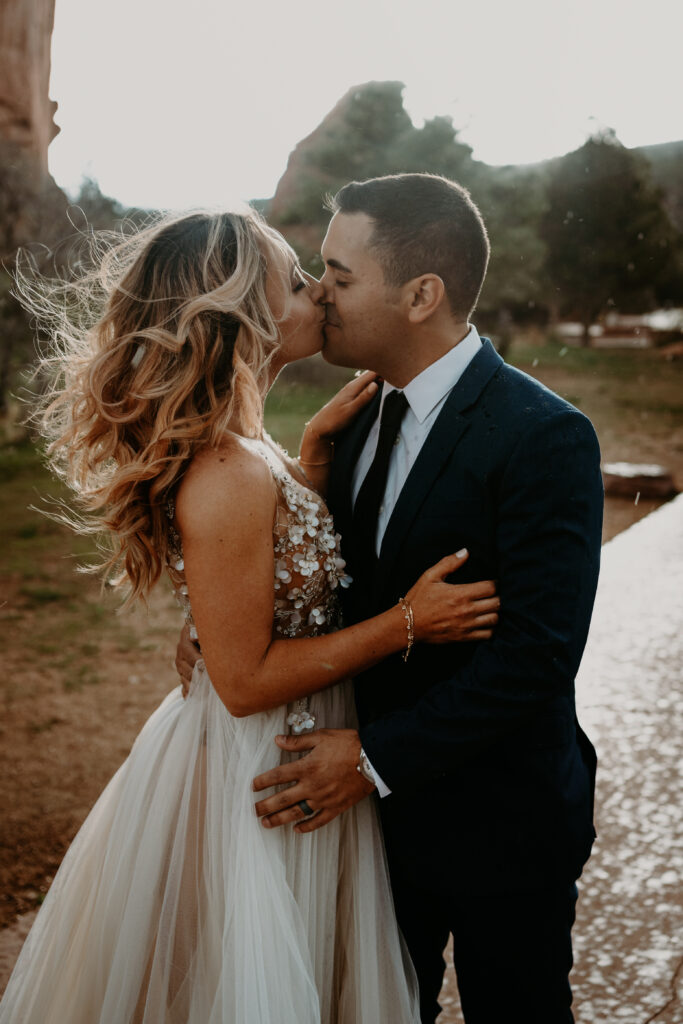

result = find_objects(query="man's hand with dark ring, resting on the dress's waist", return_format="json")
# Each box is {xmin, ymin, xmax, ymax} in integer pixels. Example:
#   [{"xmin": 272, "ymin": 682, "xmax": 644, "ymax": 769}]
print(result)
[{"xmin": 254, "ymin": 729, "xmax": 375, "ymax": 833}]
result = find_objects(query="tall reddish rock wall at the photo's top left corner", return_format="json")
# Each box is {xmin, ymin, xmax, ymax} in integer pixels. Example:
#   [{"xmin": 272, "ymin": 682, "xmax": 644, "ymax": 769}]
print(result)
[{"xmin": 0, "ymin": 0, "xmax": 59, "ymax": 175}]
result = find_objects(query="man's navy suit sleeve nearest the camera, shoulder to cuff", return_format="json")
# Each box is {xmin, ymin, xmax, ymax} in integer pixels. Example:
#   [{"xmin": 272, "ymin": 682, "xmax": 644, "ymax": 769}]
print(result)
[{"xmin": 360, "ymin": 410, "xmax": 603, "ymax": 793}]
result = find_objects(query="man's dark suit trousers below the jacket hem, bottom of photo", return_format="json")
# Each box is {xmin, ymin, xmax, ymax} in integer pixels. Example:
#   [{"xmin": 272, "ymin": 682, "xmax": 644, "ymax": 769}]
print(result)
[{"xmin": 393, "ymin": 873, "xmax": 578, "ymax": 1024}]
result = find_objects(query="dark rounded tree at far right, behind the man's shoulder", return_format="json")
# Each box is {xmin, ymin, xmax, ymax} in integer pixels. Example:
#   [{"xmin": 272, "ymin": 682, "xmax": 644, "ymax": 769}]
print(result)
[{"xmin": 540, "ymin": 130, "xmax": 680, "ymax": 344}]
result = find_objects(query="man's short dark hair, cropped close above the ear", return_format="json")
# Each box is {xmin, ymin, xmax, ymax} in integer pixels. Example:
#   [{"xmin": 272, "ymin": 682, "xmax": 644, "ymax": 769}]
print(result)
[{"xmin": 328, "ymin": 174, "xmax": 489, "ymax": 319}]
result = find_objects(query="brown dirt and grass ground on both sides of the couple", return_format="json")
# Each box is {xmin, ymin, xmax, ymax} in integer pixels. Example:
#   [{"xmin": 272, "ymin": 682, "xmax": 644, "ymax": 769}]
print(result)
[{"xmin": 0, "ymin": 342, "xmax": 683, "ymax": 942}]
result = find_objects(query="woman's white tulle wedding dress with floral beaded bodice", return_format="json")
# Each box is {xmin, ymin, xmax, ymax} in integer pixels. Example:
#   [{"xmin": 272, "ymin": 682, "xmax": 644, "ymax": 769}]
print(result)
[{"xmin": 0, "ymin": 441, "xmax": 419, "ymax": 1024}]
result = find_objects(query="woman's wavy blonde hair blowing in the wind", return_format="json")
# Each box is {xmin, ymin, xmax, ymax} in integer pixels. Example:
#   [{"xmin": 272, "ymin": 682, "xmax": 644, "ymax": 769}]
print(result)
[{"xmin": 16, "ymin": 208, "xmax": 295, "ymax": 603}]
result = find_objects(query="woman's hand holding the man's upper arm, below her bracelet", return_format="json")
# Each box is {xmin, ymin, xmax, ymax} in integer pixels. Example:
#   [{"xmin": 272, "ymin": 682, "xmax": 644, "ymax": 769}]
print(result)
[{"xmin": 405, "ymin": 550, "xmax": 501, "ymax": 643}]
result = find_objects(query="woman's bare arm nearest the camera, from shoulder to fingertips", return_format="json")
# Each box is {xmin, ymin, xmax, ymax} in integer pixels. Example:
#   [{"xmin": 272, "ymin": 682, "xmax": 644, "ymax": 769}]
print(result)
[{"xmin": 176, "ymin": 450, "xmax": 497, "ymax": 716}]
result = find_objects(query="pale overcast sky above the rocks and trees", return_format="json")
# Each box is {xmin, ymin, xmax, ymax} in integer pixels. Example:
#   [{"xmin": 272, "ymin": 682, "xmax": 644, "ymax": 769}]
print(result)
[{"xmin": 50, "ymin": 0, "xmax": 683, "ymax": 208}]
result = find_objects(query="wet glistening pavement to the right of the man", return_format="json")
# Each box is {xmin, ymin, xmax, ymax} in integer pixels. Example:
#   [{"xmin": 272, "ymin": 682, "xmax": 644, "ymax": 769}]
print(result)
[{"xmin": 439, "ymin": 495, "xmax": 683, "ymax": 1024}]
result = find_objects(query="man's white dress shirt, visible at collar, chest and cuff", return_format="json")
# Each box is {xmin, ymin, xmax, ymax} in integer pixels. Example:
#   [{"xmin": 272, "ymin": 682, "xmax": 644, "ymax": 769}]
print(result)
[{"xmin": 351, "ymin": 326, "xmax": 481, "ymax": 797}]
